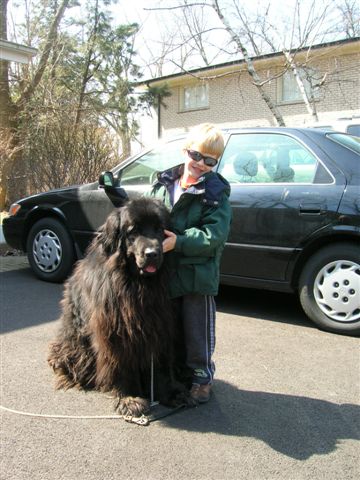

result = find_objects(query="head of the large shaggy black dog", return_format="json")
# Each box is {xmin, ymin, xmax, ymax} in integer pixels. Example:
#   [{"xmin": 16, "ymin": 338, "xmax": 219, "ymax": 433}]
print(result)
[{"xmin": 99, "ymin": 198, "xmax": 170, "ymax": 276}]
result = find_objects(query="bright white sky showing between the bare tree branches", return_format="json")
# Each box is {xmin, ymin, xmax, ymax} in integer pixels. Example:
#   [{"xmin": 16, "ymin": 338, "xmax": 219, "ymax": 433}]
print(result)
[{"xmin": 8, "ymin": 0, "xmax": 348, "ymax": 78}]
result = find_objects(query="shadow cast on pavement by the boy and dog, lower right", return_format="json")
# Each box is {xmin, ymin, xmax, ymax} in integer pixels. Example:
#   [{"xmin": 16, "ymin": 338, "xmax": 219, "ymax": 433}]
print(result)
[{"xmin": 161, "ymin": 380, "xmax": 360, "ymax": 460}]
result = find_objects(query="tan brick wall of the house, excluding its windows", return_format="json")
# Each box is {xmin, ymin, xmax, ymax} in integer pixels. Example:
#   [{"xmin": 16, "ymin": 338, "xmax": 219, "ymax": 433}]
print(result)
[{"xmin": 161, "ymin": 49, "xmax": 360, "ymax": 136}]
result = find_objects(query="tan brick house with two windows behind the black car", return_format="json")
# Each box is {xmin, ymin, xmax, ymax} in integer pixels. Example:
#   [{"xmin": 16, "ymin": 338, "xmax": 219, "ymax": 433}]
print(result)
[{"xmin": 139, "ymin": 38, "xmax": 360, "ymax": 141}]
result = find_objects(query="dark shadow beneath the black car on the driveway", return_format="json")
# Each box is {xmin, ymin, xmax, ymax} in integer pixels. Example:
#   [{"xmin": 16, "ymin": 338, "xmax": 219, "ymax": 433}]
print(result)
[{"xmin": 0, "ymin": 257, "xmax": 315, "ymax": 333}]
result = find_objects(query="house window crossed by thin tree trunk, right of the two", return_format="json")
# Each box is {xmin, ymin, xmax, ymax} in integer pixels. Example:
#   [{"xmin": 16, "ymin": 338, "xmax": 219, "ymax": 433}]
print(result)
[{"xmin": 280, "ymin": 68, "xmax": 320, "ymax": 102}]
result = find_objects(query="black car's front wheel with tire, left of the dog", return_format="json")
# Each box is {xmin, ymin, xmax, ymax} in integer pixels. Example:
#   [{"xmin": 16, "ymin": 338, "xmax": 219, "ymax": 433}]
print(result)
[{"xmin": 26, "ymin": 217, "xmax": 76, "ymax": 282}]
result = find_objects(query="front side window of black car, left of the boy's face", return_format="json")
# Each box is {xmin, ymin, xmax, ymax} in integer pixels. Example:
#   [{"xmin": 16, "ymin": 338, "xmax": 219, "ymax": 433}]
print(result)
[{"xmin": 120, "ymin": 139, "xmax": 184, "ymax": 187}]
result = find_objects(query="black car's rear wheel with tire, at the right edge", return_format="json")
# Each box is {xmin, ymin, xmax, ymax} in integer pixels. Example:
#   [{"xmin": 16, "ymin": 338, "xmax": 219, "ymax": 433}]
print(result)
[{"xmin": 299, "ymin": 242, "xmax": 360, "ymax": 336}]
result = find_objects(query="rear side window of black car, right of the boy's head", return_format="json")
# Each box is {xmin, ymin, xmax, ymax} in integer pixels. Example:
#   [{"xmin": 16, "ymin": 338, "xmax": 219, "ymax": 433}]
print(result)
[{"xmin": 218, "ymin": 133, "xmax": 332, "ymax": 184}]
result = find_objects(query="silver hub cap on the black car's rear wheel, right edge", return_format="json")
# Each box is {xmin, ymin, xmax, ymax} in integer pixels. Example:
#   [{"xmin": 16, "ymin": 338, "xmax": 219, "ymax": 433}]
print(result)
[{"xmin": 314, "ymin": 260, "xmax": 360, "ymax": 322}]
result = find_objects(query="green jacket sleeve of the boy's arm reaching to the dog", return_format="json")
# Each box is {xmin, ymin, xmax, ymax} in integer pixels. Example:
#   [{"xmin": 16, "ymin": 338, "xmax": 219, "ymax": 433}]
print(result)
[{"xmin": 175, "ymin": 193, "xmax": 231, "ymax": 257}]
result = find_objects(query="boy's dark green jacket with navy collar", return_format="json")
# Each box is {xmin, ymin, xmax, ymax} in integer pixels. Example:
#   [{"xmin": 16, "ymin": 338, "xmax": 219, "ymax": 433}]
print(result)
[{"xmin": 151, "ymin": 165, "xmax": 231, "ymax": 298}]
